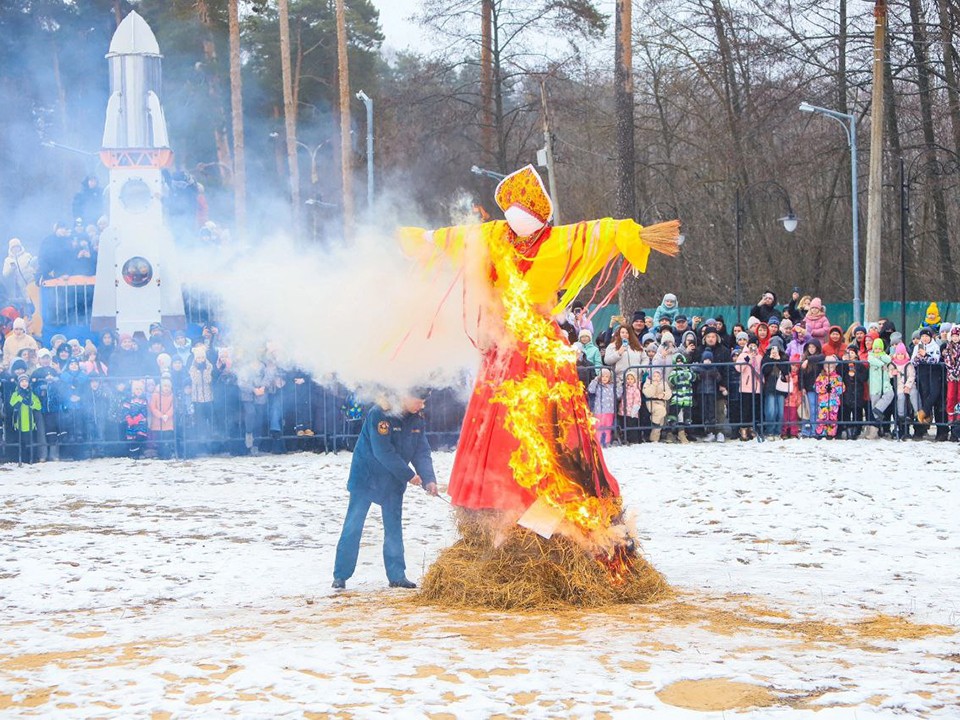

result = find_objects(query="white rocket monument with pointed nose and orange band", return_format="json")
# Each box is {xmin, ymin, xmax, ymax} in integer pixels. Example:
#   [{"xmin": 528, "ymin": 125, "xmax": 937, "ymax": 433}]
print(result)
[{"xmin": 91, "ymin": 12, "xmax": 185, "ymax": 333}]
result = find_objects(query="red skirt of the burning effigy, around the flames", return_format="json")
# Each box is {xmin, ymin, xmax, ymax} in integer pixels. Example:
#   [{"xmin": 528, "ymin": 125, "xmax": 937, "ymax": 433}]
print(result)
[{"xmin": 449, "ymin": 338, "xmax": 620, "ymax": 512}]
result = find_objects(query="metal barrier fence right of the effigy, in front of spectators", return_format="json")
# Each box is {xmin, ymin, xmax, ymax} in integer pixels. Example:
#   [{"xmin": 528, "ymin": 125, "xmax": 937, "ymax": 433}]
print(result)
[{"xmin": 604, "ymin": 360, "xmax": 960, "ymax": 443}]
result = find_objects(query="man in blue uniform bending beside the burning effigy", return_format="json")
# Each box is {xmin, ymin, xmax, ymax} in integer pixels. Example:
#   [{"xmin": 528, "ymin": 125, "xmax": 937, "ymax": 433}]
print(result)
[{"xmin": 333, "ymin": 391, "xmax": 437, "ymax": 589}]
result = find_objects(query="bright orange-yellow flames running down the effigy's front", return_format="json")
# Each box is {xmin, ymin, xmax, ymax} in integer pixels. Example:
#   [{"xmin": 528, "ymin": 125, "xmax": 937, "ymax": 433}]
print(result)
[{"xmin": 488, "ymin": 235, "xmax": 621, "ymax": 537}]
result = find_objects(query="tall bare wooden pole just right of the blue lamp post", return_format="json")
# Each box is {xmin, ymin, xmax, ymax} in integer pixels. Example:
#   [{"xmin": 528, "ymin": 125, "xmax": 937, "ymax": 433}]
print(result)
[{"xmin": 863, "ymin": 0, "xmax": 887, "ymax": 321}]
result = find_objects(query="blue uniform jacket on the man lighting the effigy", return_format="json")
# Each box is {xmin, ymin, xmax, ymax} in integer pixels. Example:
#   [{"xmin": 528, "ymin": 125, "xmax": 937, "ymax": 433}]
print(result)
[{"xmin": 347, "ymin": 405, "xmax": 437, "ymax": 504}]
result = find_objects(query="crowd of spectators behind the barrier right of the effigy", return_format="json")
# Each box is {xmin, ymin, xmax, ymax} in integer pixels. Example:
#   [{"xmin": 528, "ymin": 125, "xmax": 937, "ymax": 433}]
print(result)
[{"xmin": 561, "ymin": 291, "xmax": 960, "ymax": 445}]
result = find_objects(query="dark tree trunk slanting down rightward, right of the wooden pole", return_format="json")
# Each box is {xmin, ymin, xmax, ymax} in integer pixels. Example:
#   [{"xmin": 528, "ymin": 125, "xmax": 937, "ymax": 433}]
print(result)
[{"xmin": 910, "ymin": 0, "xmax": 960, "ymax": 298}]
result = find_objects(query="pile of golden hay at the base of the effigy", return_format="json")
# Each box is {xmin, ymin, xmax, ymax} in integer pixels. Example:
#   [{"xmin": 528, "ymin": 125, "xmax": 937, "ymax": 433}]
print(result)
[{"xmin": 420, "ymin": 517, "xmax": 670, "ymax": 610}]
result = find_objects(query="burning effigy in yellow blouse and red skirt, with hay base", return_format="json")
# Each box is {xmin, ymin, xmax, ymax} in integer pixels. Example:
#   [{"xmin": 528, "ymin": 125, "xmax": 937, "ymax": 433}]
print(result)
[{"xmin": 402, "ymin": 166, "xmax": 679, "ymax": 609}]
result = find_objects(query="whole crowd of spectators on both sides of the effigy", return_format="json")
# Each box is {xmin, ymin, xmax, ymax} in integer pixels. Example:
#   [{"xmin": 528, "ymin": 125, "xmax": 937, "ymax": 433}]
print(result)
[{"xmin": 0, "ymin": 200, "xmax": 960, "ymax": 462}]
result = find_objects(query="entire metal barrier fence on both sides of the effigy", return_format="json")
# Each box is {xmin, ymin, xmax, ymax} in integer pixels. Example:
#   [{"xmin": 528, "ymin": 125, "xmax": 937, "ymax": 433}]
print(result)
[{"xmin": 0, "ymin": 361, "xmax": 960, "ymax": 462}]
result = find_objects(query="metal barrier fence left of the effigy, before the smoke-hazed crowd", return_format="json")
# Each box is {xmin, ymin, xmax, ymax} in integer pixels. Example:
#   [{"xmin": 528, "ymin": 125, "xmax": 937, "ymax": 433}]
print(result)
[{"xmin": 0, "ymin": 373, "xmax": 465, "ymax": 462}]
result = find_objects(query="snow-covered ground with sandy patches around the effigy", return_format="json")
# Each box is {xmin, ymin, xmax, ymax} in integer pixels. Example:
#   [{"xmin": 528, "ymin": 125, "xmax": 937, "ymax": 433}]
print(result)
[{"xmin": 0, "ymin": 440, "xmax": 960, "ymax": 720}]
